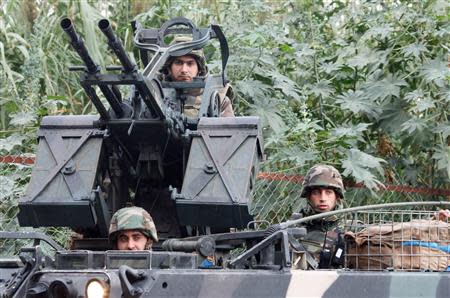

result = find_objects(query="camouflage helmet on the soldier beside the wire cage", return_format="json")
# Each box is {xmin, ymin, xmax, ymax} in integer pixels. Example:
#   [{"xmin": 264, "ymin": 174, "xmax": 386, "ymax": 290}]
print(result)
[{"xmin": 300, "ymin": 164, "xmax": 345, "ymax": 199}]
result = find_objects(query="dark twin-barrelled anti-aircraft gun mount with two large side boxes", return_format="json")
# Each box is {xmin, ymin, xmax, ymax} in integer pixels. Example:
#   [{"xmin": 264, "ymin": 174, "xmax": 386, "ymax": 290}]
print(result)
[{"xmin": 18, "ymin": 18, "xmax": 263, "ymax": 239}]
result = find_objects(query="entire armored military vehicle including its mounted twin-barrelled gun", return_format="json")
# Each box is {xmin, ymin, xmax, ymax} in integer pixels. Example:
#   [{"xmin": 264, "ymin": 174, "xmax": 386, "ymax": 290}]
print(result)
[{"xmin": 0, "ymin": 18, "xmax": 450, "ymax": 298}]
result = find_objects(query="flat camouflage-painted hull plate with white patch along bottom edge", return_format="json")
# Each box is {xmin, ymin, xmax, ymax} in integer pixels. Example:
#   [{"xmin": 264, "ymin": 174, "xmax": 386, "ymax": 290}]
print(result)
[{"xmin": 10, "ymin": 269, "xmax": 450, "ymax": 298}]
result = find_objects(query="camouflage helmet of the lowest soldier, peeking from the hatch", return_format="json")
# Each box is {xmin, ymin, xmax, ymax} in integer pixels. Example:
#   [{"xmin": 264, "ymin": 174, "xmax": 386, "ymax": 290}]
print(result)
[{"xmin": 109, "ymin": 207, "xmax": 158, "ymax": 243}]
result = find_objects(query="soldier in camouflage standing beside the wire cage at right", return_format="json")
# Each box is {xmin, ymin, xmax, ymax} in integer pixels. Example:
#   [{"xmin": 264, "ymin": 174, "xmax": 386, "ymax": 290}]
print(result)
[{"xmin": 299, "ymin": 164, "xmax": 345, "ymax": 268}]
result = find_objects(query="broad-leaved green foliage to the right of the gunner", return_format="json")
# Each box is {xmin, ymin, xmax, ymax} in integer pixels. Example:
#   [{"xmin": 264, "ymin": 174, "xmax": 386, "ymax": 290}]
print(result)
[{"xmin": 229, "ymin": 2, "xmax": 450, "ymax": 193}]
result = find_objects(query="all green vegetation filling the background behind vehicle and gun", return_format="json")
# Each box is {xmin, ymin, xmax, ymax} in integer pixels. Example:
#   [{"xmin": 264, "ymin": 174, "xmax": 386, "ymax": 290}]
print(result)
[{"xmin": 0, "ymin": 0, "xmax": 450, "ymax": 248}]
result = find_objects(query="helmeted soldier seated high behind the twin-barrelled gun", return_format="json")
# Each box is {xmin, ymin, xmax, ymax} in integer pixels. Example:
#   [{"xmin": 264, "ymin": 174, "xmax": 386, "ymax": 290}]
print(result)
[{"xmin": 161, "ymin": 36, "xmax": 234, "ymax": 117}]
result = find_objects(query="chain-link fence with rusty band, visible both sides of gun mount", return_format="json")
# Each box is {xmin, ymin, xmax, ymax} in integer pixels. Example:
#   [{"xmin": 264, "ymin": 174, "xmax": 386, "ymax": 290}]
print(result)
[{"xmin": 0, "ymin": 156, "xmax": 450, "ymax": 250}]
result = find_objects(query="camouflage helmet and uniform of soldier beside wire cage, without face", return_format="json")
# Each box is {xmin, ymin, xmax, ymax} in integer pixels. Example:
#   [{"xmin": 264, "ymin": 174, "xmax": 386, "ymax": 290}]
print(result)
[{"xmin": 299, "ymin": 165, "xmax": 345, "ymax": 268}]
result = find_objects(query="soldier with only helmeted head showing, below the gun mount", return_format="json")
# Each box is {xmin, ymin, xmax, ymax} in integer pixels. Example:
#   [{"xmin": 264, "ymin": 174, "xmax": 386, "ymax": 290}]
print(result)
[{"xmin": 109, "ymin": 207, "xmax": 158, "ymax": 250}]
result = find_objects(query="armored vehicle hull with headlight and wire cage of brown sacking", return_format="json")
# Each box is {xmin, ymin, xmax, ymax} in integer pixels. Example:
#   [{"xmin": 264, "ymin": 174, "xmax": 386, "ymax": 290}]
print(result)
[{"xmin": 0, "ymin": 202, "xmax": 450, "ymax": 297}]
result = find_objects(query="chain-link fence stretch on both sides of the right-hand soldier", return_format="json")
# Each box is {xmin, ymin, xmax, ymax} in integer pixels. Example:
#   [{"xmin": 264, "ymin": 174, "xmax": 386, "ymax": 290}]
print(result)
[{"xmin": 250, "ymin": 171, "xmax": 450, "ymax": 227}]
